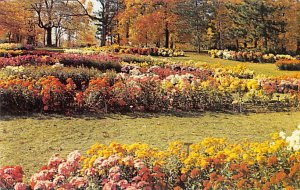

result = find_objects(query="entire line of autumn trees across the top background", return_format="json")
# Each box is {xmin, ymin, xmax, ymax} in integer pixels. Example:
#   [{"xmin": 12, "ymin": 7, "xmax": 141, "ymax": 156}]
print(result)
[{"xmin": 0, "ymin": 0, "xmax": 300, "ymax": 54}]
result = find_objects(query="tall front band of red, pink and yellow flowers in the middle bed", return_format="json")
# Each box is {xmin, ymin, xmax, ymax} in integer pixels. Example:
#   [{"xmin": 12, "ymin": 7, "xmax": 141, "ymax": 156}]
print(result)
[{"xmin": 0, "ymin": 68, "xmax": 300, "ymax": 112}]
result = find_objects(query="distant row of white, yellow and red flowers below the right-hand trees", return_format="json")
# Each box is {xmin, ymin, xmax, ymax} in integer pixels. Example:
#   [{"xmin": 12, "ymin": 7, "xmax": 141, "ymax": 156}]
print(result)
[{"xmin": 208, "ymin": 50, "xmax": 296, "ymax": 63}]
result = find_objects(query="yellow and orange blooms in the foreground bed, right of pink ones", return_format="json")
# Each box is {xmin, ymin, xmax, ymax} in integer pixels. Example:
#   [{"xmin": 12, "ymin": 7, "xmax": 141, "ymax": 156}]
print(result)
[{"xmin": 82, "ymin": 134, "xmax": 300, "ymax": 189}]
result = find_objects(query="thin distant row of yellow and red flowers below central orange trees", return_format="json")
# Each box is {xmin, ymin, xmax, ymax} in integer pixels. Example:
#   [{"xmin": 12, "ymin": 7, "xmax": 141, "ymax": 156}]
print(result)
[{"xmin": 65, "ymin": 46, "xmax": 184, "ymax": 57}]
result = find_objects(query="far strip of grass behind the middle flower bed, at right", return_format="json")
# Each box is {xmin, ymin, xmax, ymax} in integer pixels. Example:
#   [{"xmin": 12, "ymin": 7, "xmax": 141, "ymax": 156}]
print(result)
[{"xmin": 162, "ymin": 53, "xmax": 300, "ymax": 76}]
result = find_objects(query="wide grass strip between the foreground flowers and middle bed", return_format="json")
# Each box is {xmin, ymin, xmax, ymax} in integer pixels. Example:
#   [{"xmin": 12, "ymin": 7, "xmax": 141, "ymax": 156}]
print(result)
[{"xmin": 0, "ymin": 112, "xmax": 300, "ymax": 179}]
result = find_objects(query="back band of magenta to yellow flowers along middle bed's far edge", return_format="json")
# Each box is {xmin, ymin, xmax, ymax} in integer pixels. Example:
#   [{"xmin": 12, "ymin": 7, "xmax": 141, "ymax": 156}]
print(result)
[{"xmin": 0, "ymin": 51, "xmax": 254, "ymax": 78}]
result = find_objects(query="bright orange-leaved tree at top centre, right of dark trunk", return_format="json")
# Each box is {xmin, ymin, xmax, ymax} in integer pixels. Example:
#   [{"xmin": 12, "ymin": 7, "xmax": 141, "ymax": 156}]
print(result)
[{"xmin": 118, "ymin": 0, "xmax": 179, "ymax": 47}]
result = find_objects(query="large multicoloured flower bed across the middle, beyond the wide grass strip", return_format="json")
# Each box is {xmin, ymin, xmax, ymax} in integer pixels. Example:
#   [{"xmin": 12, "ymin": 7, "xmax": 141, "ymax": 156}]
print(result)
[{"xmin": 0, "ymin": 43, "xmax": 300, "ymax": 113}]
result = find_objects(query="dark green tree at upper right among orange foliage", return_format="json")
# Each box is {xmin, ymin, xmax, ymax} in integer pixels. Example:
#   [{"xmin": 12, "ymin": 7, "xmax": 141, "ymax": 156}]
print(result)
[{"xmin": 227, "ymin": 0, "xmax": 286, "ymax": 49}]
